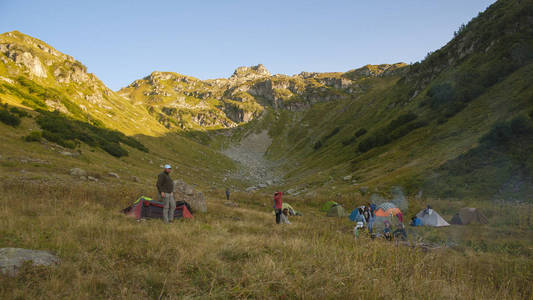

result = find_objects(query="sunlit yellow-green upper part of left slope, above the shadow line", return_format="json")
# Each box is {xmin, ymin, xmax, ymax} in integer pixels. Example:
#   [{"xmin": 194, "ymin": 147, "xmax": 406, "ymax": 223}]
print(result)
[{"xmin": 0, "ymin": 31, "xmax": 165, "ymax": 135}]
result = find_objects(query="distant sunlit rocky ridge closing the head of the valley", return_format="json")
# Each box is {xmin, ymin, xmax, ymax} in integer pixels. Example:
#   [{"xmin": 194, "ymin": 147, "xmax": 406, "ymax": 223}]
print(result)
[{"xmin": 119, "ymin": 63, "xmax": 407, "ymax": 129}]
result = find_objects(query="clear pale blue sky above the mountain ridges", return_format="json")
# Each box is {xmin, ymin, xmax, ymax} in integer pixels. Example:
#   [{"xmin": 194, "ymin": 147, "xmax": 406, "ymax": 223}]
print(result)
[{"xmin": 0, "ymin": 0, "xmax": 495, "ymax": 90}]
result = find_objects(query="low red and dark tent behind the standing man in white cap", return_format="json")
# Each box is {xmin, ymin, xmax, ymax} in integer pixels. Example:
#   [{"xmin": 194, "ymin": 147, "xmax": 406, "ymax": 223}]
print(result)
[{"xmin": 122, "ymin": 196, "xmax": 193, "ymax": 220}]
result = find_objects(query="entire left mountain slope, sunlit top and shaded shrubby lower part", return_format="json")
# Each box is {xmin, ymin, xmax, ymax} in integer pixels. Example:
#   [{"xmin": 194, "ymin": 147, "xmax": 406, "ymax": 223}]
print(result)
[{"xmin": 0, "ymin": 31, "xmax": 239, "ymax": 192}]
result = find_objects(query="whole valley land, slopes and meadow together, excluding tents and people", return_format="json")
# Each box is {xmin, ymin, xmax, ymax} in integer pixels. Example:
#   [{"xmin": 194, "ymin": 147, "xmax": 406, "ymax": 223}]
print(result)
[{"xmin": 0, "ymin": 0, "xmax": 533, "ymax": 299}]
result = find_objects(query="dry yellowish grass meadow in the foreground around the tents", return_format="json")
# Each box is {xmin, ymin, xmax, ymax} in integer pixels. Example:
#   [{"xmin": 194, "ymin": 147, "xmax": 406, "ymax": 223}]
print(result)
[{"xmin": 0, "ymin": 180, "xmax": 533, "ymax": 299}]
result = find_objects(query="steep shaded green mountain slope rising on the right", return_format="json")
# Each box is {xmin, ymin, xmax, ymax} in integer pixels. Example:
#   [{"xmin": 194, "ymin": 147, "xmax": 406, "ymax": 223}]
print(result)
[{"xmin": 207, "ymin": 1, "xmax": 533, "ymax": 200}]
